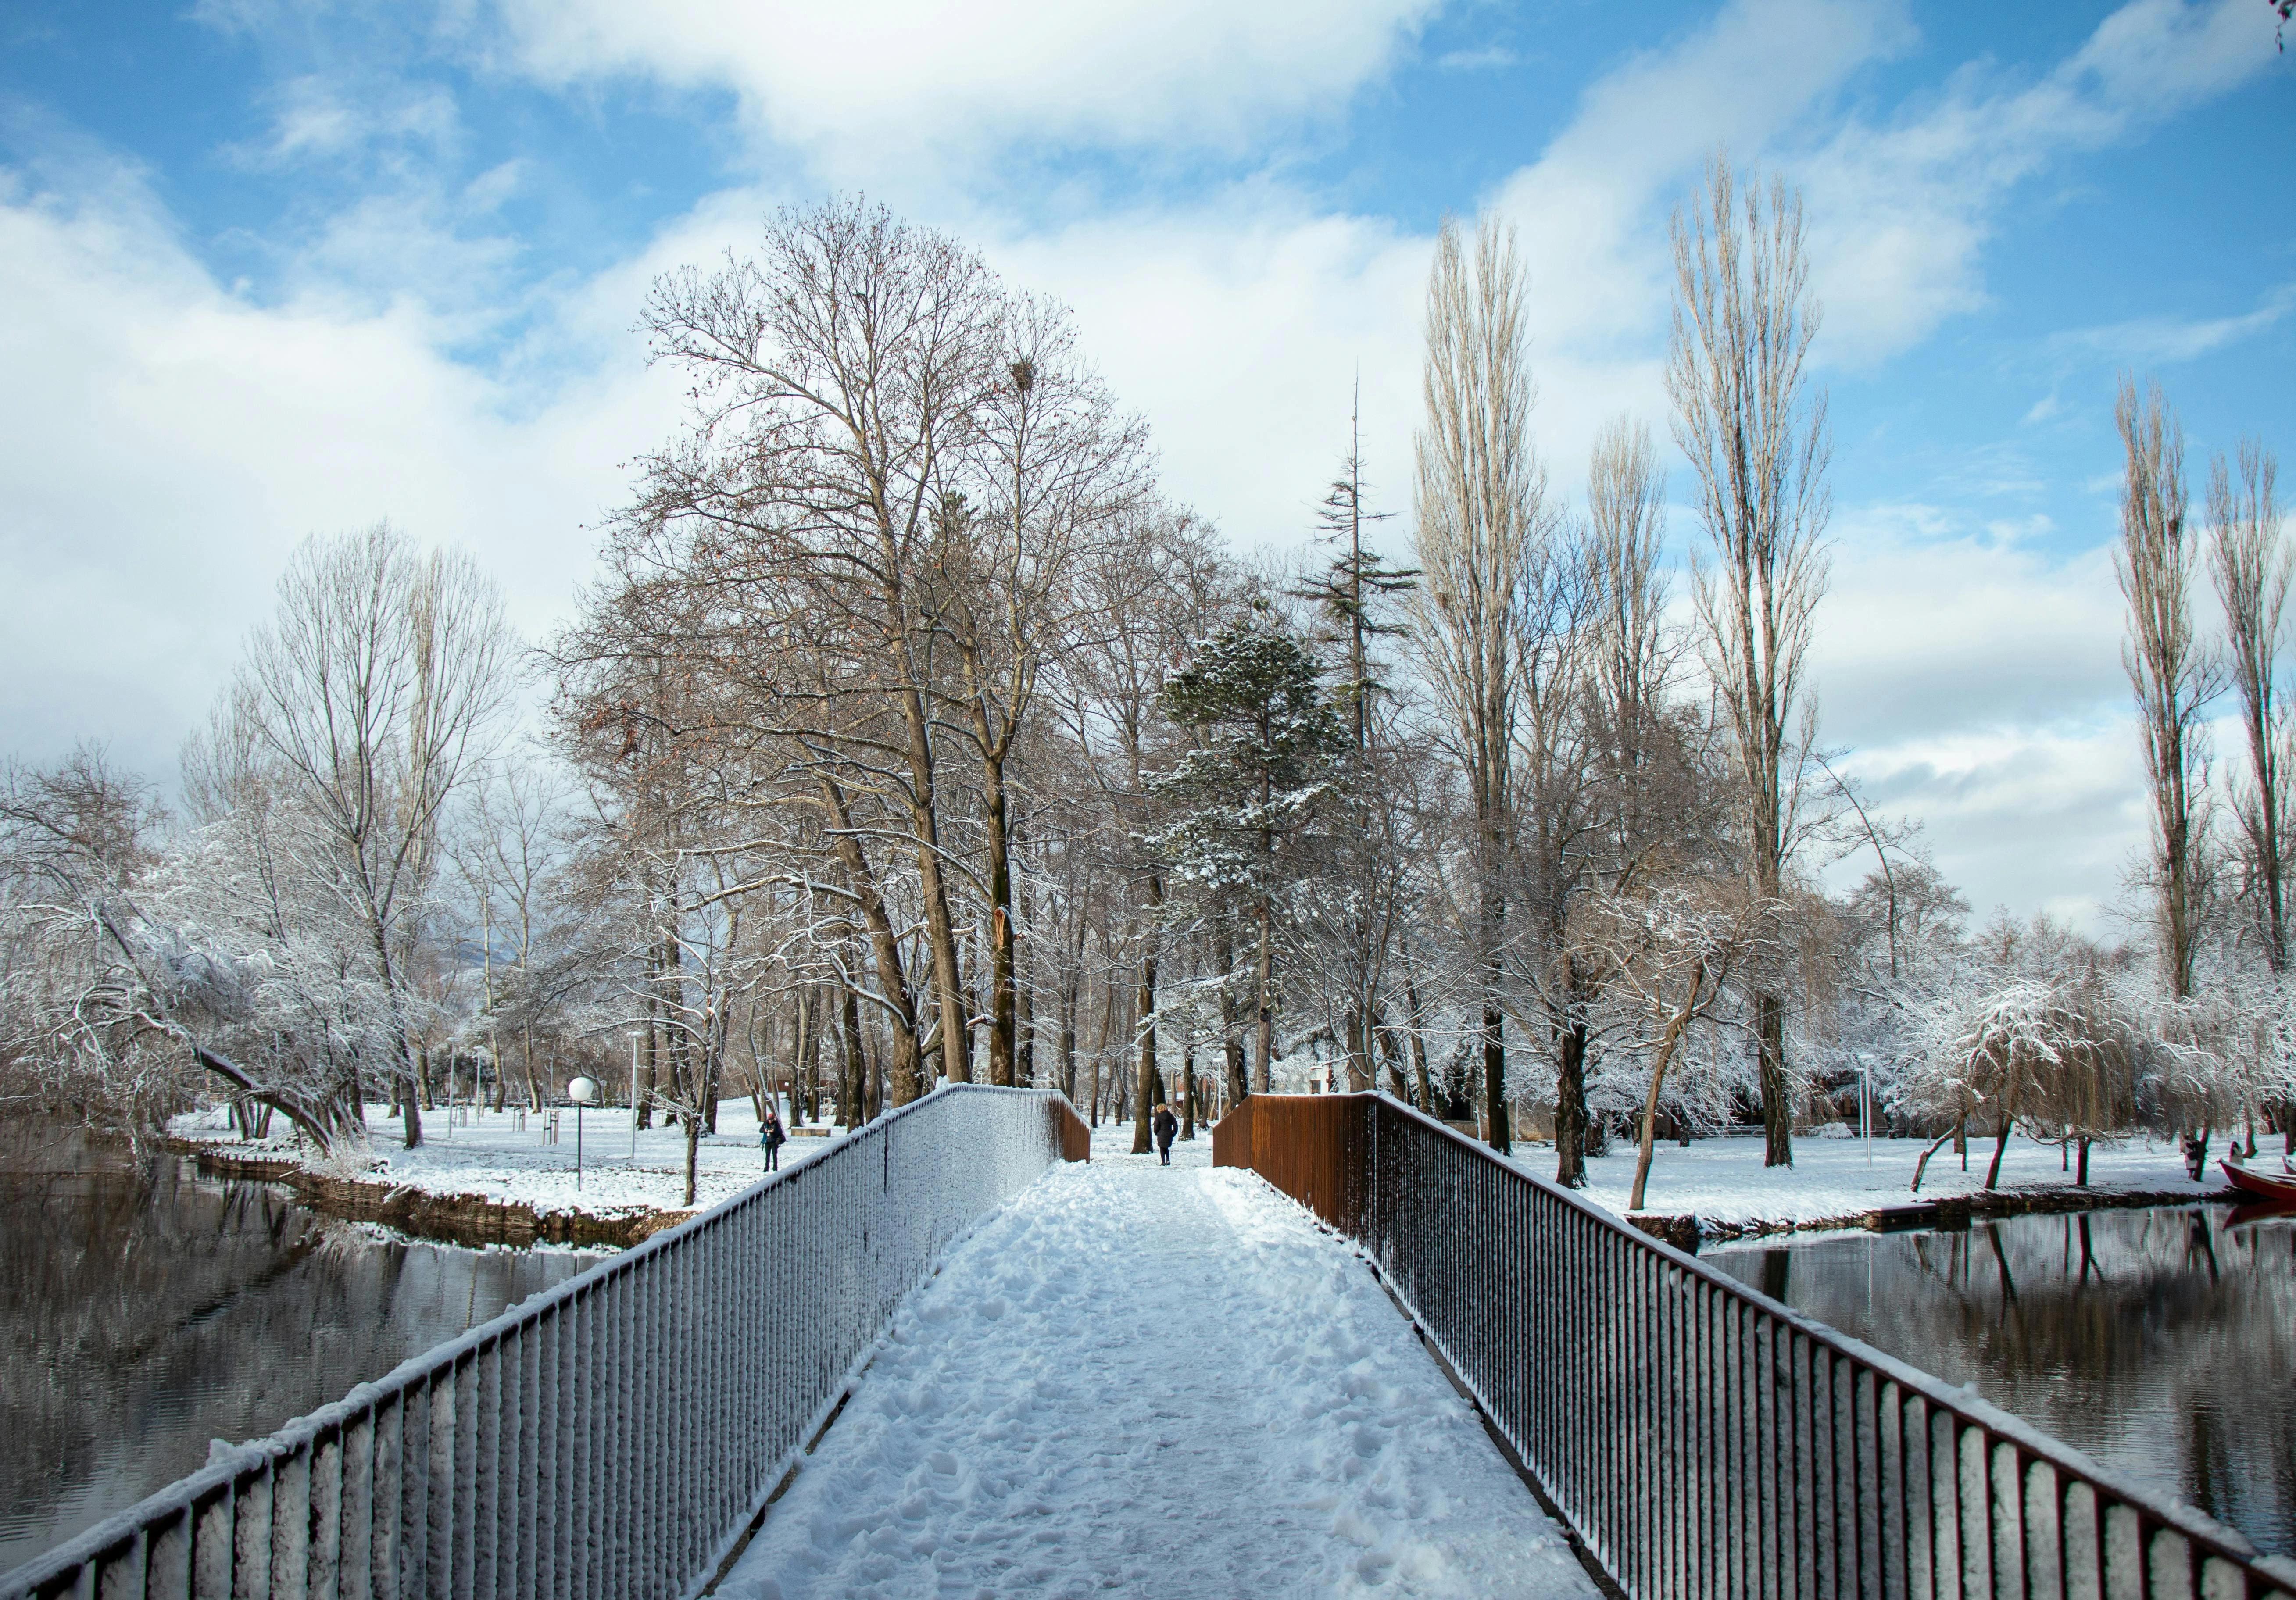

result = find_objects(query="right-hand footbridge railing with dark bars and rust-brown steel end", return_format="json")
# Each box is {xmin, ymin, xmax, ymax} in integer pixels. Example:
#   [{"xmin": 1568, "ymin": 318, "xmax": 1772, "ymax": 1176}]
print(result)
[{"xmin": 1212, "ymin": 1095, "xmax": 2296, "ymax": 1600}]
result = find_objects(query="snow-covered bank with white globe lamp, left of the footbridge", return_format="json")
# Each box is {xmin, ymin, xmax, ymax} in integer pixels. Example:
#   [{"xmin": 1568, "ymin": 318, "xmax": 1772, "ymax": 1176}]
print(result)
[{"xmin": 170, "ymin": 1100, "xmax": 838, "ymax": 1217}]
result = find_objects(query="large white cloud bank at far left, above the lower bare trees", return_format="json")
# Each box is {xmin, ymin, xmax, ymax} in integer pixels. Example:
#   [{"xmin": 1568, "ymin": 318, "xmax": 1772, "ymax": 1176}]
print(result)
[{"xmin": 0, "ymin": 161, "xmax": 675, "ymax": 771}]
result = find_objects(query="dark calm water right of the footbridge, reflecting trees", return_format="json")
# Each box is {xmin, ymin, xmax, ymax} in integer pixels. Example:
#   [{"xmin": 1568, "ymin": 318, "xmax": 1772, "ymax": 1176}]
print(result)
[{"xmin": 1708, "ymin": 1205, "xmax": 2296, "ymax": 1554}]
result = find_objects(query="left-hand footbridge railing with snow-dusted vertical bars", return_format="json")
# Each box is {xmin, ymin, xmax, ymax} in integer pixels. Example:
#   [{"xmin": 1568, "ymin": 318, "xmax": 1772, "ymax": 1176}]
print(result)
[{"xmin": 0, "ymin": 1083, "xmax": 1088, "ymax": 1600}]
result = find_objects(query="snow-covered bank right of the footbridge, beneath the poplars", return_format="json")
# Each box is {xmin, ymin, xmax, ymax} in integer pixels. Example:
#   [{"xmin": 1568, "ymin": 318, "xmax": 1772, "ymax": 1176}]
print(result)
[{"xmin": 1515, "ymin": 1115, "xmax": 2232, "ymax": 1228}]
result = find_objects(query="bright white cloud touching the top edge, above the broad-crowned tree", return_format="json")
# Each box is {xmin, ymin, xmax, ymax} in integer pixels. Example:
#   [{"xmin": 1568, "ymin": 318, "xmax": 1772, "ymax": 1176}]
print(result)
[{"xmin": 503, "ymin": 0, "xmax": 1437, "ymax": 177}]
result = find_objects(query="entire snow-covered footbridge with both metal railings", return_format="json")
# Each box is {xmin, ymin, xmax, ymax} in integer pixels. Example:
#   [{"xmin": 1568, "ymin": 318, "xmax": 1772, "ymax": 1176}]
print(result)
[{"xmin": 0, "ymin": 1086, "xmax": 2296, "ymax": 1600}]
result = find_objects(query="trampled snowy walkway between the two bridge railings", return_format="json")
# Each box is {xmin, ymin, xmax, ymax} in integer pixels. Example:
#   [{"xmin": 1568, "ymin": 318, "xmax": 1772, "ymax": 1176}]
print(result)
[{"xmin": 719, "ymin": 1139, "xmax": 1593, "ymax": 1600}]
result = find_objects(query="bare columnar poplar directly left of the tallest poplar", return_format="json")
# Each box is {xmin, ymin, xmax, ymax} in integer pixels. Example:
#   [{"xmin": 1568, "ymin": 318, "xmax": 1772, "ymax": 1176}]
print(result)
[{"xmin": 1412, "ymin": 218, "xmax": 1554, "ymax": 1150}]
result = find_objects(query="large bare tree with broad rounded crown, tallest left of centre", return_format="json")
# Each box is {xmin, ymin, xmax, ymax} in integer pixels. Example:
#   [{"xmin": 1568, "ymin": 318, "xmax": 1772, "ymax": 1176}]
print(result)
[{"xmin": 631, "ymin": 202, "xmax": 1010, "ymax": 1081}]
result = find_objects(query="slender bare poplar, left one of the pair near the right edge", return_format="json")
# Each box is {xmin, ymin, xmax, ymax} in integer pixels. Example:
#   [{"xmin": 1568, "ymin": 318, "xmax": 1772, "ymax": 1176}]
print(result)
[{"xmin": 2112, "ymin": 376, "xmax": 2218, "ymax": 999}]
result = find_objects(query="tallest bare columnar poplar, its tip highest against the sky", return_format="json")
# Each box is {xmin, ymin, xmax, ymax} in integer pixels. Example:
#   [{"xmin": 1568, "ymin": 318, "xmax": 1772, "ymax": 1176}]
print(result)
[{"xmin": 1667, "ymin": 156, "xmax": 1832, "ymax": 1166}]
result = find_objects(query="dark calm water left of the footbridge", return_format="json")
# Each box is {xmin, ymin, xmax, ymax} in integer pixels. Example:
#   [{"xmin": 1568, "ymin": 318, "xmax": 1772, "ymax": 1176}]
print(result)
[{"xmin": 0, "ymin": 1122, "xmax": 592, "ymax": 1572}]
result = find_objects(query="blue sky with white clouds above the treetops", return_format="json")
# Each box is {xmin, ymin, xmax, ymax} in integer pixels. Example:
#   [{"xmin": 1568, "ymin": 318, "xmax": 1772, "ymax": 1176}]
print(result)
[{"xmin": 0, "ymin": 0, "xmax": 2296, "ymax": 927}]
